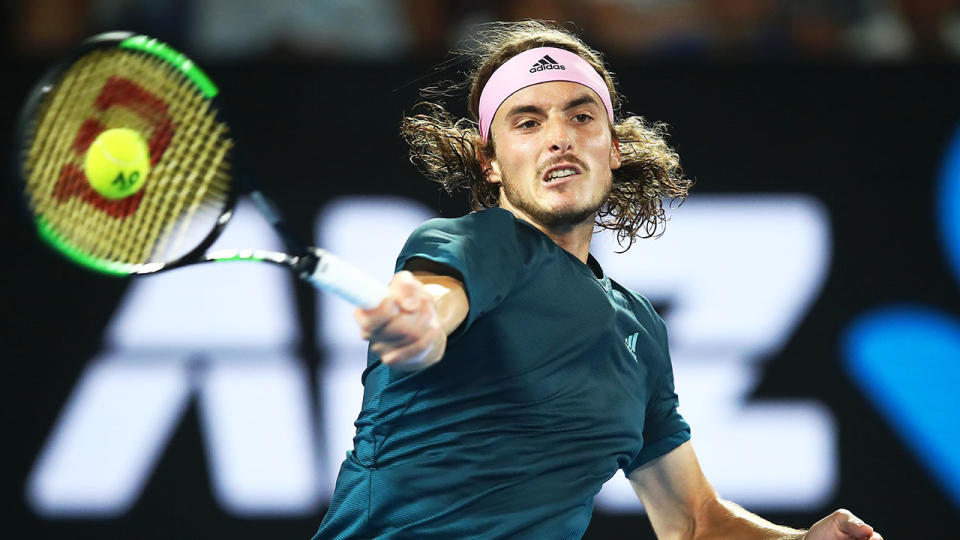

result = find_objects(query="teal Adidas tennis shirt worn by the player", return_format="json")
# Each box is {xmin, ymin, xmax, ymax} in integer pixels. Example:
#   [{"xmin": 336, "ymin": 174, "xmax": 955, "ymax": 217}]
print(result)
[{"xmin": 314, "ymin": 208, "xmax": 690, "ymax": 540}]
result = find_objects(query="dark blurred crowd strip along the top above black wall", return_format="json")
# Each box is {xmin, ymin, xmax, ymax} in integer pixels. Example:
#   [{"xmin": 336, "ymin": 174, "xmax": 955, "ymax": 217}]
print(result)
[{"xmin": 4, "ymin": 0, "xmax": 960, "ymax": 61}]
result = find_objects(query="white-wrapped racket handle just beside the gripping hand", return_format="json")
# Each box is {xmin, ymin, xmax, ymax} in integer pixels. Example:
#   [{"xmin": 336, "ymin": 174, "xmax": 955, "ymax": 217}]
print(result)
[{"xmin": 301, "ymin": 248, "xmax": 387, "ymax": 309}]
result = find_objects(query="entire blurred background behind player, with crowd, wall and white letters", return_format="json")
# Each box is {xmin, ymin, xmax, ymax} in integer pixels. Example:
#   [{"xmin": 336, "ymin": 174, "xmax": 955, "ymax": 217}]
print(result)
[{"xmin": 0, "ymin": 0, "xmax": 960, "ymax": 539}]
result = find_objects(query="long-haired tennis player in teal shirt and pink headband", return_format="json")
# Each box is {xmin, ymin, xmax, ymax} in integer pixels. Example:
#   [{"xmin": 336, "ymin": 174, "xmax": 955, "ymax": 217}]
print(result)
[{"xmin": 314, "ymin": 22, "xmax": 880, "ymax": 540}]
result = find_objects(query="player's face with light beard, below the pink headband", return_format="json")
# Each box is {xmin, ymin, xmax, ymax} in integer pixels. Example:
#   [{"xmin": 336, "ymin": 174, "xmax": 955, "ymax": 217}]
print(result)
[{"xmin": 487, "ymin": 81, "xmax": 620, "ymax": 228}]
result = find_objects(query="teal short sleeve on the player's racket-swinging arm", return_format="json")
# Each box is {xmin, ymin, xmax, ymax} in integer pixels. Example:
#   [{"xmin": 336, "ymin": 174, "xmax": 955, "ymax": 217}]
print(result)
[{"xmin": 396, "ymin": 208, "xmax": 535, "ymax": 332}]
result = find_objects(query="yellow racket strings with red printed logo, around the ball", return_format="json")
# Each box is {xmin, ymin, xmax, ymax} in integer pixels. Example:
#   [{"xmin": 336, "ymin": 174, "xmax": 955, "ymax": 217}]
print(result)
[{"xmin": 25, "ymin": 50, "xmax": 232, "ymax": 265}]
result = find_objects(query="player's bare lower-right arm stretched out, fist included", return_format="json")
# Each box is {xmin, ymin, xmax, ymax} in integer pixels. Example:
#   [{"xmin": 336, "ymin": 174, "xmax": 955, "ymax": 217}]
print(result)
[{"xmin": 629, "ymin": 442, "xmax": 883, "ymax": 540}]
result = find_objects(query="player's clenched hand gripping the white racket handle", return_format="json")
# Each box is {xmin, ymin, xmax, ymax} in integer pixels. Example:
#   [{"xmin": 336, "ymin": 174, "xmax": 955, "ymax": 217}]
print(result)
[{"xmin": 353, "ymin": 271, "xmax": 447, "ymax": 370}]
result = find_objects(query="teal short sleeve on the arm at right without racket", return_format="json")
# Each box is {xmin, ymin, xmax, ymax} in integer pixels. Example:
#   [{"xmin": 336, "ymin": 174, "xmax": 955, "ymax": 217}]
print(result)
[{"xmin": 623, "ymin": 317, "xmax": 690, "ymax": 475}]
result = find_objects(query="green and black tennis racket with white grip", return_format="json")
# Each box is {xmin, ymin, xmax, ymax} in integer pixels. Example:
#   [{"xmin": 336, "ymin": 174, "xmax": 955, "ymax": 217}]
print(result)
[{"xmin": 16, "ymin": 32, "xmax": 386, "ymax": 308}]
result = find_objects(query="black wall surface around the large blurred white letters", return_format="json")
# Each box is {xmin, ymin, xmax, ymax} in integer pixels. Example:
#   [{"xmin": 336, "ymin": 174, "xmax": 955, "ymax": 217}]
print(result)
[{"xmin": 0, "ymin": 2, "xmax": 960, "ymax": 540}]
